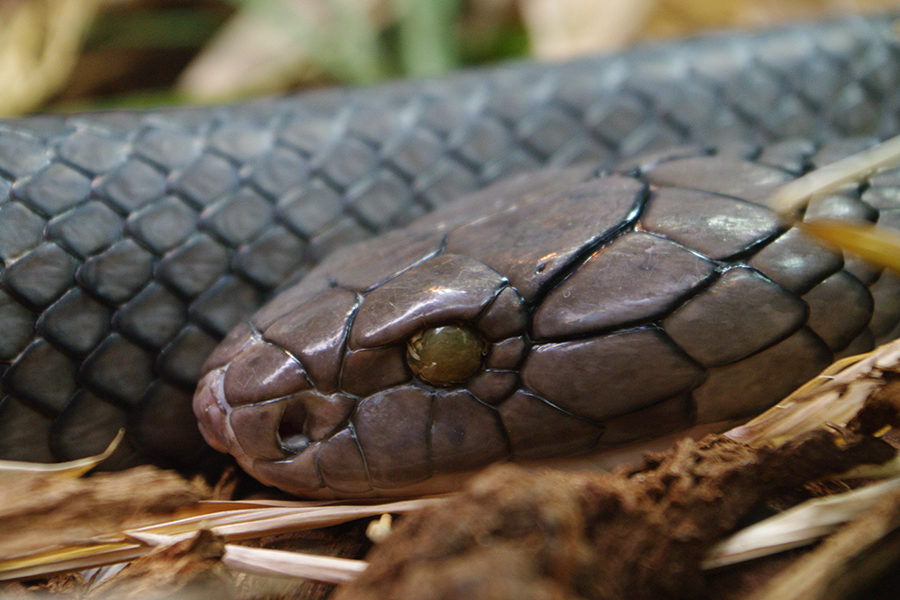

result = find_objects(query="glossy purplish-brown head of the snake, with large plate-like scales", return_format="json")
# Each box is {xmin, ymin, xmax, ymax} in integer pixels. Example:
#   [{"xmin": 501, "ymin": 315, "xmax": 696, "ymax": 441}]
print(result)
[{"xmin": 194, "ymin": 168, "xmax": 782, "ymax": 497}]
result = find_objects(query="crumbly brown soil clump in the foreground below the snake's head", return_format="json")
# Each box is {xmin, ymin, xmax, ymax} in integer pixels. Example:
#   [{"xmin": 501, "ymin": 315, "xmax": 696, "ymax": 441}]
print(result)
[{"xmin": 335, "ymin": 428, "xmax": 894, "ymax": 600}]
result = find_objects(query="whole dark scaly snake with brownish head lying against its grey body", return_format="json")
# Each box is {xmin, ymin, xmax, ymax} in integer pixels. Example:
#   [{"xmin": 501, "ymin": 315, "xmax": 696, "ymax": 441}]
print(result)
[{"xmin": 0, "ymin": 16, "xmax": 900, "ymax": 497}]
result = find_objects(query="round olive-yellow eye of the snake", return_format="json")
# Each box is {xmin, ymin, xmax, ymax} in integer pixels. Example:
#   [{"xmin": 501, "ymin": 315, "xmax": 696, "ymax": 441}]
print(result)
[{"xmin": 406, "ymin": 325, "xmax": 485, "ymax": 386}]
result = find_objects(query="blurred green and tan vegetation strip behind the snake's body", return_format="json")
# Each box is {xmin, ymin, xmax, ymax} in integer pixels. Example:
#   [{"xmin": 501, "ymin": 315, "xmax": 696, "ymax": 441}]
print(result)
[{"xmin": 0, "ymin": 0, "xmax": 900, "ymax": 116}]
